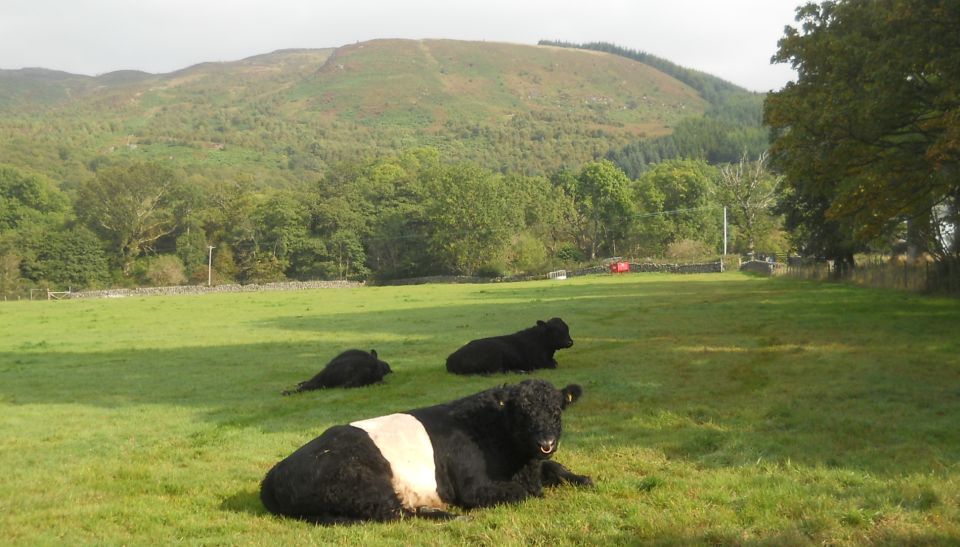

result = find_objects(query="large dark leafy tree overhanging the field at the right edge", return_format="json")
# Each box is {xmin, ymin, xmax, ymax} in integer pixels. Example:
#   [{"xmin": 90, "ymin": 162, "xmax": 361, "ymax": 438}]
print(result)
[{"xmin": 764, "ymin": 0, "xmax": 960, "ymax": 266}]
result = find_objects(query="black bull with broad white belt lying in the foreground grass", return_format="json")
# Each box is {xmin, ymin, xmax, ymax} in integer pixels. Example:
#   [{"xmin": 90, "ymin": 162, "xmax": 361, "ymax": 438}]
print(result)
[{"xmin": 260, "ymin": 380, "xmax": 593, "ymax": 524}]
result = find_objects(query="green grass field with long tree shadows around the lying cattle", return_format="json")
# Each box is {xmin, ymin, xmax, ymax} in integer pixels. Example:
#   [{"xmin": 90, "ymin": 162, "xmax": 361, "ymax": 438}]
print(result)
[{"xmin": 0, "ymin": 274, "xmax": 960, "ymax": 545}]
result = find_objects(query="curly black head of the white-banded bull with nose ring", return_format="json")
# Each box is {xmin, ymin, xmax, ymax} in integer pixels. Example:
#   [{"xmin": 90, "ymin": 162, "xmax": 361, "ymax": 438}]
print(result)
[{"xmin": 500, "ymin": 380, "xmax": 583, "ymax": 459}]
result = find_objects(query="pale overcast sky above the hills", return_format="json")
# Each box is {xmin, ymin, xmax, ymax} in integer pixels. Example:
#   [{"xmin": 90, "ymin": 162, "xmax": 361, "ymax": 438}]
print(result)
[{"xmin": 0, "ymin": 0, "xmax": 804, "ymax": 91}]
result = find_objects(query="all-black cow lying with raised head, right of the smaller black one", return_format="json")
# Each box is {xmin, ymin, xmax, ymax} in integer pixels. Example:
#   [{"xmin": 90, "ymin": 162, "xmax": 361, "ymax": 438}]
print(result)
[{"xmin": 447, "ymin": 317, "xmax": 573, "ymax": 374}]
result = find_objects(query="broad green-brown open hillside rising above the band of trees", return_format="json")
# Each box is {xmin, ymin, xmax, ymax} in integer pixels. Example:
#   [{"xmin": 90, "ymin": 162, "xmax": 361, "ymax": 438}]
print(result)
[{"xmin": 0, "ymin": 40, "xmax": 708, "ymax": 185}]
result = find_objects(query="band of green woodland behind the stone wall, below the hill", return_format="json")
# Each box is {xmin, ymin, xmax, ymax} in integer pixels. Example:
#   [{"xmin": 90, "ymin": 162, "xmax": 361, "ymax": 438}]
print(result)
[{"xmin": 0, "ymin": 148, "xmax": 785, "ymax": 294}]
